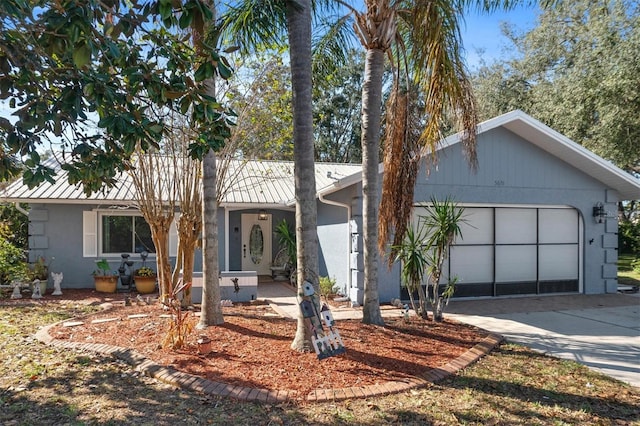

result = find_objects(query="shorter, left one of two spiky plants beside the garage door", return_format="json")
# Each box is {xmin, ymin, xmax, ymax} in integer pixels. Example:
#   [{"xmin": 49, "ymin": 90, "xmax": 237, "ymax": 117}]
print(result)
[{"xmin": 393, "ymin": 224, "xmax": 428, "ymax": 319}]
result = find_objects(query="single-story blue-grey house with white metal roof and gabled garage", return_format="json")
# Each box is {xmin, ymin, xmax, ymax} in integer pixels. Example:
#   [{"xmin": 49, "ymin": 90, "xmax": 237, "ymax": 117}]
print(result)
[{"xmin": 1, "ymin": 111, "xmax": 640, "ymax": 303}]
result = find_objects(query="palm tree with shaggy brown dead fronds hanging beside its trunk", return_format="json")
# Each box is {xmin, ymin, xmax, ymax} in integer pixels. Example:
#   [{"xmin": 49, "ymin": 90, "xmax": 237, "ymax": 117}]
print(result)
[{"xmin": 337, "ymin": 0, "xmax": 553, "ymax": 324}]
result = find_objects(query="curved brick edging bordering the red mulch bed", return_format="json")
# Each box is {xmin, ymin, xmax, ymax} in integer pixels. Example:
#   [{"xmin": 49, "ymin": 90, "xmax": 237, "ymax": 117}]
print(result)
[{"xmin": 35, "ymin": 324, "xmax": 504, "ymax": 403}]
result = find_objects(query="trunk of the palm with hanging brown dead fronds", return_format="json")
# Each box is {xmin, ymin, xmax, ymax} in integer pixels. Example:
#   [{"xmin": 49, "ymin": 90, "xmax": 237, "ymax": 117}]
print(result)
[{"xmin": 362, "ymin": 49, "xmax": 385, "ymax": 325}]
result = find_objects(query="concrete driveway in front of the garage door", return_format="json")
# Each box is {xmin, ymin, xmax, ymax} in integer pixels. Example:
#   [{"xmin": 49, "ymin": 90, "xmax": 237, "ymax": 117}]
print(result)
[{"xmin": 445, "ymin": 293, "xmax": 640, "ymax": 387}]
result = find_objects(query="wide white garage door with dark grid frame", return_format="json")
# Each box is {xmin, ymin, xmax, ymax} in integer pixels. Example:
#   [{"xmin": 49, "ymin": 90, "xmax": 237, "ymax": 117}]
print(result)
[{"xmin": 416, "ymin": 206, "xmax": 581, "ymax": 297}]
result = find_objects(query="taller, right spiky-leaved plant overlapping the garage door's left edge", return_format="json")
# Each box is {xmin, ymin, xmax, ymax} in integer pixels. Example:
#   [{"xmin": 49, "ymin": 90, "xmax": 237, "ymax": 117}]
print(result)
[{"xmin": 420, "ymin": 197, "xmax": 466, "ymax": 321}]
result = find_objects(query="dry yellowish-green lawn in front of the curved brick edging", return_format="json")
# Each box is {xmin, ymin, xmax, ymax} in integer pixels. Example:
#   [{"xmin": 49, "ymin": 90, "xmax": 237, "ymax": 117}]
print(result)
[{"xmin": 0, "ymin": 305, "xmax": 640, "ymax": 425}]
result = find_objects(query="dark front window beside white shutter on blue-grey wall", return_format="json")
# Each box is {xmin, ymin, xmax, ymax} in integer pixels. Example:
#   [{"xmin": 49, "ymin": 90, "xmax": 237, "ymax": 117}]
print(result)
[{"xmin": 100, "ymin": 213, "xmax": 156, "ymax": 254}]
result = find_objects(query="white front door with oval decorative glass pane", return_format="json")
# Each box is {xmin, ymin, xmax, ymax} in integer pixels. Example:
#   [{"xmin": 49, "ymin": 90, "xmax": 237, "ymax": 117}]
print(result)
[{"xmin": 240, "ymin": 214, "xmax": 272, "ymax": 275}]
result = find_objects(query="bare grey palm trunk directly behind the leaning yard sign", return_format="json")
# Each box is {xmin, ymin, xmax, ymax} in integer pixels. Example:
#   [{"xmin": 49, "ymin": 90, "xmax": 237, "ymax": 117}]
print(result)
[{"xmin": 287, "ymin": 0, "xmax": 319, "ymax": 351}]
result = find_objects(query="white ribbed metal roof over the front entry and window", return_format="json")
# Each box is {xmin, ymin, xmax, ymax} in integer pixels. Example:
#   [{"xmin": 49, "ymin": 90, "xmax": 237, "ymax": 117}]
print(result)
[{"xmin": 0, "ymin": 160, "xmax": 362, "ymax": 206}]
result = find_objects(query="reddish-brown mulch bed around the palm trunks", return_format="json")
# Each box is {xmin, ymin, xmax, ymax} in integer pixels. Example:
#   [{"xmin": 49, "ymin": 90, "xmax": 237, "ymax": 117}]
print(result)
[{"xmin": 5, "ymin": 290, "xmax": 486, "ymax": 396}]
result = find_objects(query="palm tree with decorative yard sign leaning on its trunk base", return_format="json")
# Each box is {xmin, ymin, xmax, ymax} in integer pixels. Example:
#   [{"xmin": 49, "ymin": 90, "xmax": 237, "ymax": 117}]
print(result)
[{"xmin": 223, "ymin": 0, "xmax": 319, "ymax": 351}]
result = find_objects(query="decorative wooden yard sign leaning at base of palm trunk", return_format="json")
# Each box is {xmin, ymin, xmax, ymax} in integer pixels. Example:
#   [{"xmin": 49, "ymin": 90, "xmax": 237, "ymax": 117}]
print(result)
[{"xmin": 300, "ymin": 281, "xmax": 346, "ymax": 359}]
